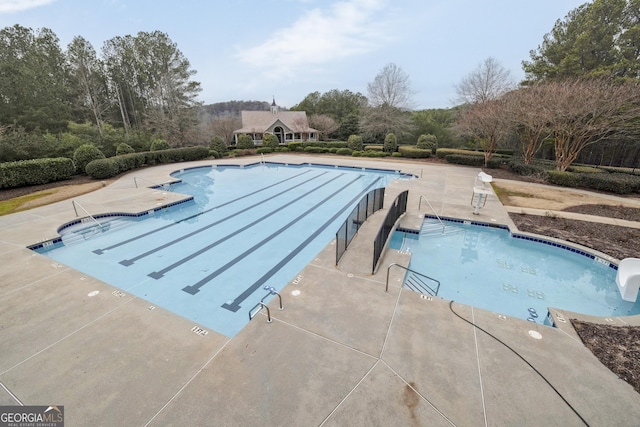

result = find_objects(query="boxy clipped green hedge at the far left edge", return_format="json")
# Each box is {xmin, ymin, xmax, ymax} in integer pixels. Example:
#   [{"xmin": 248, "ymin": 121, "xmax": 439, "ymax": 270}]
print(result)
[{"xmin": 0, "ymin": 157, "xmax": 75, "ymax": 188}]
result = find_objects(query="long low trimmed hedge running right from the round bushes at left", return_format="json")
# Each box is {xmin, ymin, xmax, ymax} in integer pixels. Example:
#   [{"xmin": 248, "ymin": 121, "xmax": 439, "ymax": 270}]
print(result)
[{"xmin": 86, "ymin": 147, "xmax": 209, "ymax": 179}]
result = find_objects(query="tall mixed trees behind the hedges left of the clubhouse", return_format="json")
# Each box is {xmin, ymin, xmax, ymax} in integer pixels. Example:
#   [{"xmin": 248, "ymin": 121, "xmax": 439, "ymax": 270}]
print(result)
[{"xmin": 0, "ymin": 25, "xmax": 200, "ymax": 154}]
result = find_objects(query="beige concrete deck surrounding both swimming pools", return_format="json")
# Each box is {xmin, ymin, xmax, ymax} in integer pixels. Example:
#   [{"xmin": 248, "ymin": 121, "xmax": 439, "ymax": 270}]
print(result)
[{"xmin": 0, "ymin": 154, "xmax": 640, "ymax": 426}]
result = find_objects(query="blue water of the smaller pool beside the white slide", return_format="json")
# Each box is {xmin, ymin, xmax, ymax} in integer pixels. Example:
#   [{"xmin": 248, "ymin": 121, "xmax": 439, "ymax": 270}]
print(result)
[{"xmin": 390, "ymin": 218, "xmax": 640, "ymax": 323}]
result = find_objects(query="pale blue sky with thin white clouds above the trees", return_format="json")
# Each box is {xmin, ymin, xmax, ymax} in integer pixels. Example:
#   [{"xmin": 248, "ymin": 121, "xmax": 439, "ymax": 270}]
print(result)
[{"xmin": 0, "ymin": 0, "xmax": 587, "ymax": 110}]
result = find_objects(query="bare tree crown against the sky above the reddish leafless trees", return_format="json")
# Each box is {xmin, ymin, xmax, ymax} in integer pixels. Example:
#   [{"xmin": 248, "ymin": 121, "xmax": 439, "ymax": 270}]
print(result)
[{"xmin": 456, "ymin": 57, "xmax": 514, "ymax": 104}]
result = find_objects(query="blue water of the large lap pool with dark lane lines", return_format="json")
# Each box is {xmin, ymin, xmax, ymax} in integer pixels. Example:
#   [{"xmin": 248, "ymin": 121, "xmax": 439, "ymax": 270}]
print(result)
[{"xmin": 32, "ymin": 163, "xmax": 406, "ymax": 337}]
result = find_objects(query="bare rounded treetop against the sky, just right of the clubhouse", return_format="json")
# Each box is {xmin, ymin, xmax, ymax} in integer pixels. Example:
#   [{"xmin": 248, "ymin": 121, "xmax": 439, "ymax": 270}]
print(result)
[{"xmin": 367, "ymin": 63, "xmax": 415, "ymax": 110}]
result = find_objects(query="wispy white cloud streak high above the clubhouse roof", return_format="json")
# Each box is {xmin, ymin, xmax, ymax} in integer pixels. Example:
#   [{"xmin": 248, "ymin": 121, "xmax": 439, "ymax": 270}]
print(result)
[{"xmin": 236, "ymin": 0, "xmax": 391, "ymax": 78}]
